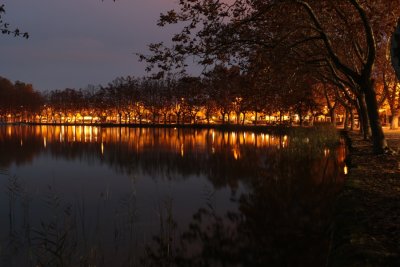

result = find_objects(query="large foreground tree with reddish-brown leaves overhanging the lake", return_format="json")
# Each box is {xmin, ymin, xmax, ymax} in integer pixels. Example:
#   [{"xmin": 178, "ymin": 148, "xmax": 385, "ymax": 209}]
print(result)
[{"xmin": 141, "ymin": 0, "xmax": 400, "ymax": 153}]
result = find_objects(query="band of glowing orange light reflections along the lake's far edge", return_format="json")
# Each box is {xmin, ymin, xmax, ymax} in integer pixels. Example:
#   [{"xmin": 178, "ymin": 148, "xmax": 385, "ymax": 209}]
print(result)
[{"xmin": 14, "ymin": 126, "xmax": 288, "ymax": 152}]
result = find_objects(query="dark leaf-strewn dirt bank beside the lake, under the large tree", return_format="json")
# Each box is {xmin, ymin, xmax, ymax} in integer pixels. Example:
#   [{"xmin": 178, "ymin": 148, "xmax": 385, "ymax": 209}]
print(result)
[{"xmin": 328, "ymin": 130, "xmax": 400, "ymax": 267}]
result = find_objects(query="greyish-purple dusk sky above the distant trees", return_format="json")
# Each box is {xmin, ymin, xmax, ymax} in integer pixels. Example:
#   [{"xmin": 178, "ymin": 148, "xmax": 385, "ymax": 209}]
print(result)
[{"xmin": 0, "ymin": 0, "xmax": 181, "ymax": 91}]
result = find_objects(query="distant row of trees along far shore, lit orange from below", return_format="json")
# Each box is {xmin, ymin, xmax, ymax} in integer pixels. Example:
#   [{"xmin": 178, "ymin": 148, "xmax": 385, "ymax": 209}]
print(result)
[{"xmin": 0, "ymin": 69, "xmax": 324, "ymax": 124}]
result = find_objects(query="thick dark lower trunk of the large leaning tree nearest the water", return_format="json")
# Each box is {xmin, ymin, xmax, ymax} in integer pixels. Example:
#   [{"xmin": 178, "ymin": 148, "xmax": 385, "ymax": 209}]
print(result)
[{"xmin": 363, "ymin": 81, "xmax": 387, "ymax": 154}]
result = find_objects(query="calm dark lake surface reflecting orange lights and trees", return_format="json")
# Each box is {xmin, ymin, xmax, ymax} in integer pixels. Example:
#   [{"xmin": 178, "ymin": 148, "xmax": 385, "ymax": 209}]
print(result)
[{"xmin": 0, "ymin": 126, "xmax": 345, "ymax": 266}]
